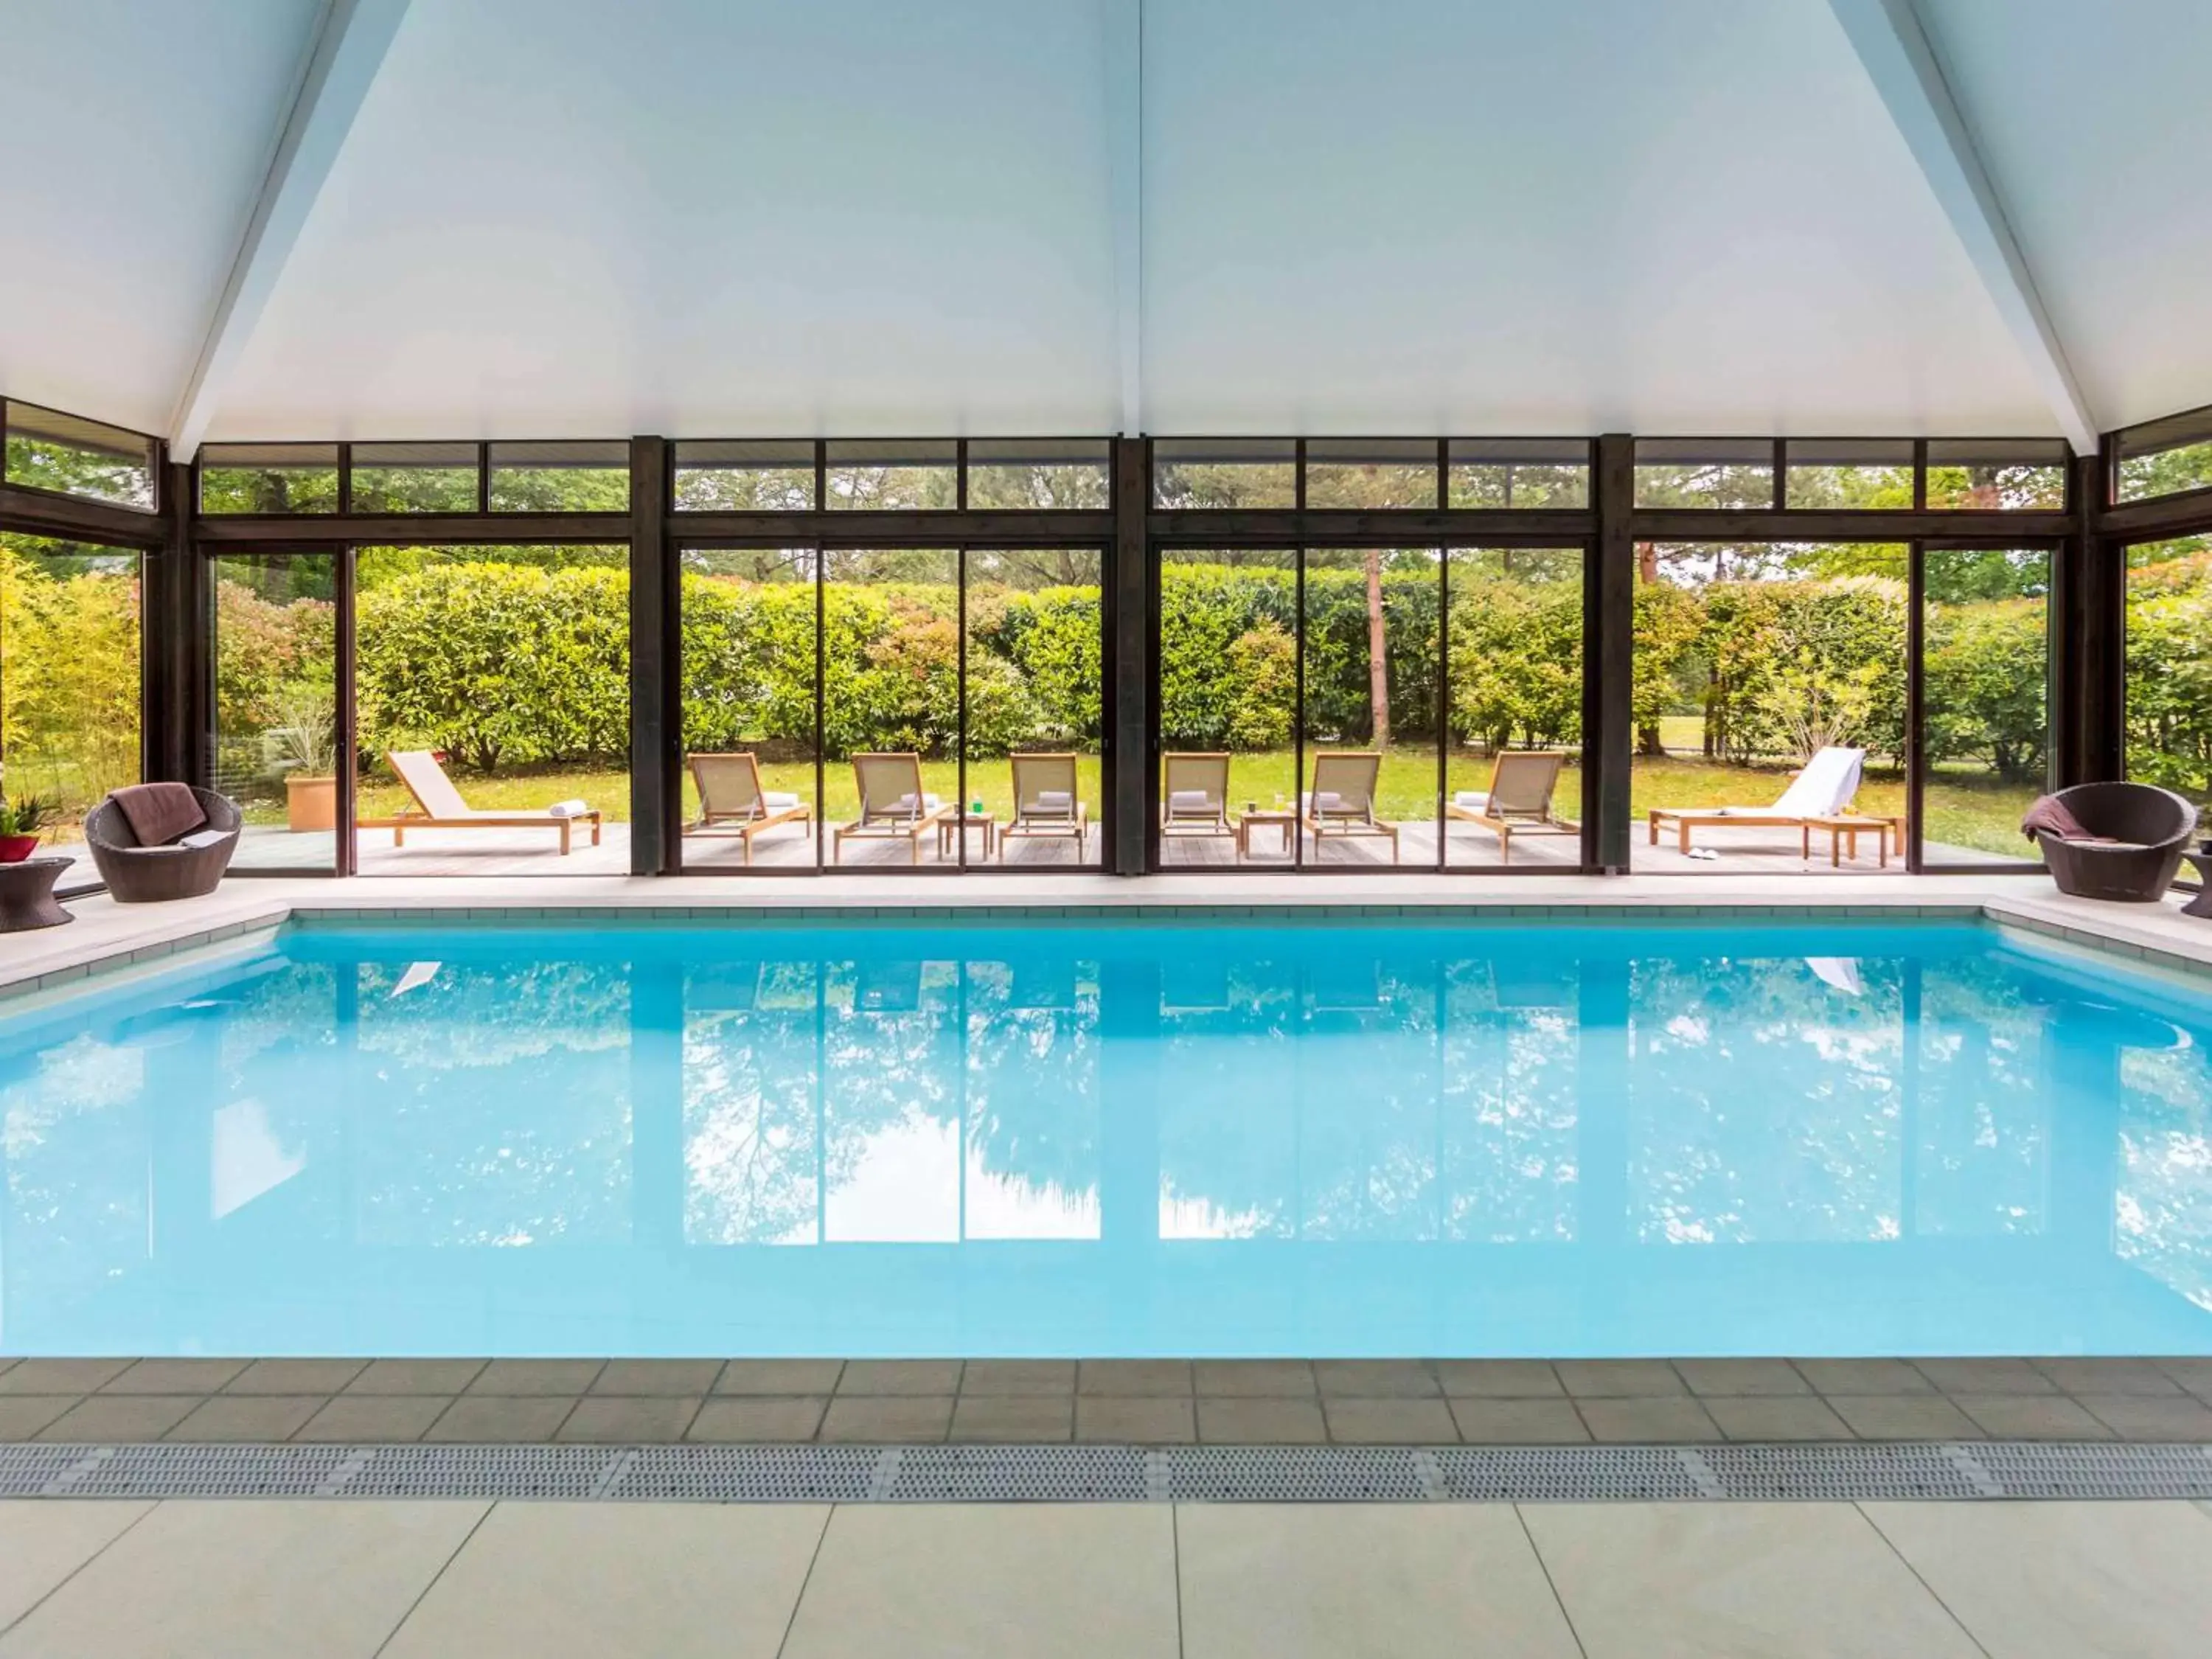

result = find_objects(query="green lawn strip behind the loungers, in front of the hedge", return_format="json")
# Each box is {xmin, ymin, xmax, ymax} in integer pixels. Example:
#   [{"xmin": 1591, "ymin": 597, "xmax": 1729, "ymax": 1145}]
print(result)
[{"xmin": 349, "ymin": 752, "xmax": 2037, "ymax": 858}]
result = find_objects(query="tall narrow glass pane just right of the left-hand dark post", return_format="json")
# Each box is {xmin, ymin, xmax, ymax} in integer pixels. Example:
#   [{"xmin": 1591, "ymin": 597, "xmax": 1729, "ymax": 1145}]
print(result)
[{"xmin": 681, "ymin": 546, "xmax": 821, "ymax": 869}]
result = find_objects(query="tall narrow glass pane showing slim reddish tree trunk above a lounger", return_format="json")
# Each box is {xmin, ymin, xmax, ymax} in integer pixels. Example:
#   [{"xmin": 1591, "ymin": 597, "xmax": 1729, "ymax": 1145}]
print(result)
[{"xmin": 1298, "ymin": 546, "xmax": 1442, "ymax": 869}]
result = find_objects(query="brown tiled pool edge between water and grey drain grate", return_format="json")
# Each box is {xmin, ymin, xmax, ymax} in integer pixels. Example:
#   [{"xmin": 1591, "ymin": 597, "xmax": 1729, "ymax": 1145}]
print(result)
[{"xmin": 0, "ymin": 1356, "xmax": 2212, "ymax": 1447}]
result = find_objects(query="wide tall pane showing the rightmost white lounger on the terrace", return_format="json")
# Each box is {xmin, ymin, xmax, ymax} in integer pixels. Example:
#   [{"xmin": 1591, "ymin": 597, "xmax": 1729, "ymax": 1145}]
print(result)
[{"xmin": 1630, "ymin": 542, "xmax": 1907, "ymax": 874}]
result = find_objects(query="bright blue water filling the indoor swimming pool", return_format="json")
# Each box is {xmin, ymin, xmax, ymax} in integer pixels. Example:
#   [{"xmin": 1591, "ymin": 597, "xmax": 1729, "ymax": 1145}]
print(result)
[{"xmin": 0, "ymin": 920, "xmax": 2212, "ymax": 1356}]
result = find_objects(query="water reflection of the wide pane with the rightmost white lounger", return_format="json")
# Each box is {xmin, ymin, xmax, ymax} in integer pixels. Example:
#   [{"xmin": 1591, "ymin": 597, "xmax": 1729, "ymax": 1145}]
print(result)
[{"xmin": 1628, "ymin": 958, "xmax": 1905, "ymax": 1243}]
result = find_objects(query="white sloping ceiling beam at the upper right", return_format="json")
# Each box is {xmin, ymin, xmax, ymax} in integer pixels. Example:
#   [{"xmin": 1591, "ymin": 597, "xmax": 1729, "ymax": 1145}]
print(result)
[{"xmin": 1827, "ymin": 0, "xmax": 2097, "ymax": 456}]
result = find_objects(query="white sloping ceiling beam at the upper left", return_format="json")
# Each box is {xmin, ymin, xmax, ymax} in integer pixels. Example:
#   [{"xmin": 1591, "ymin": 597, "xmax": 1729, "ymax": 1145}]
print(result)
[{"xmin": 168, "ymin": 0, "xmax": 407, "ymax": 460}]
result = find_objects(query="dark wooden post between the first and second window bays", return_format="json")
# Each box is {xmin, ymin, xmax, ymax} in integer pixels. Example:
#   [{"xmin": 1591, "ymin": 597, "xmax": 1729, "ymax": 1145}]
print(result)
[{"xmin": 630, "ymin": 438, "xmax": 684, "ymax": 876}]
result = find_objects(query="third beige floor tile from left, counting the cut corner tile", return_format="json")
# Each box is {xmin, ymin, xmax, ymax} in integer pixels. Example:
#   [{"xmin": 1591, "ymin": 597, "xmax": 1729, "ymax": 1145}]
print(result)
[{"xmin": 385, "ymin": 1504, "xmax": 830, "ymax": 1659}]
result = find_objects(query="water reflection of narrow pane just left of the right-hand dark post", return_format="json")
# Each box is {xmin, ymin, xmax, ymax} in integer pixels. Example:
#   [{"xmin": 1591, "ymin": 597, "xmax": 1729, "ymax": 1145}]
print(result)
[{"xmin": 1444, "ymin": 962, "xmax": 1584, "ymax": 1243}]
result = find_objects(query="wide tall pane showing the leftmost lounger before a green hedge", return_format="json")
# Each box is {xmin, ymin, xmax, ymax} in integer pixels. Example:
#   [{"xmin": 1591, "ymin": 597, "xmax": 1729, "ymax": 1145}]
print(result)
[{"xmin": 354, "ymin": 546, "xmax": 630, "ymax": 876}]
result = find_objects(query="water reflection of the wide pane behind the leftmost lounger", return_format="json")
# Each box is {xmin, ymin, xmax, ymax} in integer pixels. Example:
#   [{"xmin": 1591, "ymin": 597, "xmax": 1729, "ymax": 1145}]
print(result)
[{"xmin": 349, "ymin": 962, "xmax": 630, "ymax": 1245}]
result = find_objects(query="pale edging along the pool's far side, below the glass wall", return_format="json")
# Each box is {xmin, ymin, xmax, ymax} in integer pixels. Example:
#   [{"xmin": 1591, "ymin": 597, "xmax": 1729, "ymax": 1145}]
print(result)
[{"xmin": 13, "ymin": 876, "xmax": 2212, "ymax": 1004}]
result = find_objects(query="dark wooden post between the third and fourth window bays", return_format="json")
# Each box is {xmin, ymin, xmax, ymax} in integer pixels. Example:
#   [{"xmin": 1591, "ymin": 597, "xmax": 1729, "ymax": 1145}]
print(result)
[{"xmin": 1582, "ymin": 431, "xmax": 1637, "ymax": 876}]
